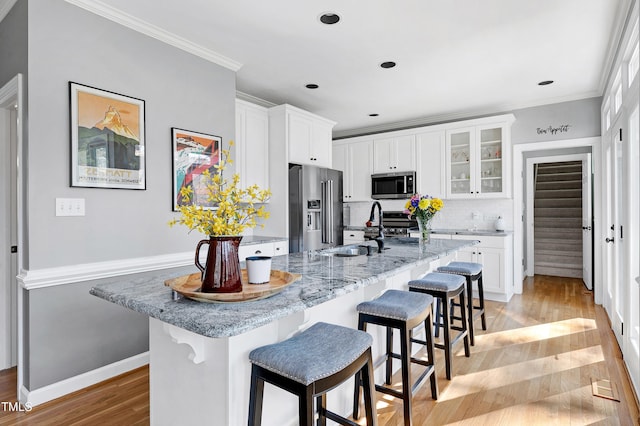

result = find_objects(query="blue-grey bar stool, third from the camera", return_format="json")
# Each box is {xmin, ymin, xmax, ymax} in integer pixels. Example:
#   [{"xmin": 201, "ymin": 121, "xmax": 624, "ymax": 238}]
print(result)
[{"xmin": 409, "ymin": 272, "xmax": 470, "ymax": 380}]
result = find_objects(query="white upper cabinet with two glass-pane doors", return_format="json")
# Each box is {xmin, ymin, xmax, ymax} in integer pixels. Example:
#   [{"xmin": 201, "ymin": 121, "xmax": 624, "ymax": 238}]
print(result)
[{"xmin": 446, "ymin": 120, "xmax": 511, "ymax": 199}]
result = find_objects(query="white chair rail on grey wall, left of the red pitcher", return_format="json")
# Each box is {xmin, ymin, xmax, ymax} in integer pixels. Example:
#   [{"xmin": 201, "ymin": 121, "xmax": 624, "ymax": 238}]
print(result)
[{"xmin": 18, "ymin": 252, "xmax": 193, "ymax": 290}]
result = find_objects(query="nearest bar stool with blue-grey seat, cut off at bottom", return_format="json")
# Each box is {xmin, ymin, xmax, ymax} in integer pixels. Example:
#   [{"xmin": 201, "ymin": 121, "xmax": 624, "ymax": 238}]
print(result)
[{"xmin": 249, "ymin": 322, "xmax": 377, "ymax": 426}]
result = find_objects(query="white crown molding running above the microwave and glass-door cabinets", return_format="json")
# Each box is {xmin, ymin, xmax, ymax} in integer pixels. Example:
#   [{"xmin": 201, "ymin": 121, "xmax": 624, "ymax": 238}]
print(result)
[{"xmin": 333, "ymin": 91, "xmax": 602, "ymax": 140}]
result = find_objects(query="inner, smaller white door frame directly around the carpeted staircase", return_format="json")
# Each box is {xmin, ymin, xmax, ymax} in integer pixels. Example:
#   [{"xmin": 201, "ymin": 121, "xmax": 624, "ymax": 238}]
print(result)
[{"xmin": 524, "ymin": 153, "xmax": 593, "ymax": 290}]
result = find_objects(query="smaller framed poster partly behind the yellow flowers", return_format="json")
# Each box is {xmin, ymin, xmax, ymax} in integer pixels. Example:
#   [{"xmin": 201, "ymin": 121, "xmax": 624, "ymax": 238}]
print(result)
[{"xmin": 171, "ymin": 127, "xmax": 222, "ymax": 210}]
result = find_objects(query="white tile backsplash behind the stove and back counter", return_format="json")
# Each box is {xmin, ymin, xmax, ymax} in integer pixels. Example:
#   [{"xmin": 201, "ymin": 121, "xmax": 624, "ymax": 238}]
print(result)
[{"xmin": 344, "ymin": 199, "xmax": 513, "ymax": 231}]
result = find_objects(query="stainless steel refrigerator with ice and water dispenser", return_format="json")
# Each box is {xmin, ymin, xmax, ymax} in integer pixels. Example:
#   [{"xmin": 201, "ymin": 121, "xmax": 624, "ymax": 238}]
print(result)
[{"xmin": 289, "ymin": 164, "xmax": 343, "ymax": 253}]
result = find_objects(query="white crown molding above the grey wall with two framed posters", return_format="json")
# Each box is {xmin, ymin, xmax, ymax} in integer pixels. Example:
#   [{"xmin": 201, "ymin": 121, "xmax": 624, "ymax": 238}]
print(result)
[{"xmin": 65, "ymin": 0, "xmax": 242, "ymax": 72}]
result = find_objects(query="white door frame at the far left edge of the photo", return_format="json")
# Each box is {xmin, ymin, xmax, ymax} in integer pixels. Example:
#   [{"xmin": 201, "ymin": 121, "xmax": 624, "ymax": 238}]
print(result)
[{"xmin": 0, "ymin": 74, "xmax": 25, "ymax": 396}]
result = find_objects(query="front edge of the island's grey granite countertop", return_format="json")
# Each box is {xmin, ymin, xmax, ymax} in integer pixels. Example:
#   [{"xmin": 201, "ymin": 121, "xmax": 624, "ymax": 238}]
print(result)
[{"xmin": 89, "ymin": 240, "xmax": 479, "ymax": 338}]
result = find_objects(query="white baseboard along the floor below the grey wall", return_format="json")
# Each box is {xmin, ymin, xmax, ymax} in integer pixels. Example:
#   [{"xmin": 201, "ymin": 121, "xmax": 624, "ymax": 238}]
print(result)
[{"xmin": 20, "ymin": 352, "xmax": 149, "ymax": 407}]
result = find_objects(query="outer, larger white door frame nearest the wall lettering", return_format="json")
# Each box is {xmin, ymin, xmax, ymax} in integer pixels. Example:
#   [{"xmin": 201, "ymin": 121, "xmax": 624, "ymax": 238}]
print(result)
[{"xmin": 512, "ymin": 136, "xmax": 602, "ymax": 304}]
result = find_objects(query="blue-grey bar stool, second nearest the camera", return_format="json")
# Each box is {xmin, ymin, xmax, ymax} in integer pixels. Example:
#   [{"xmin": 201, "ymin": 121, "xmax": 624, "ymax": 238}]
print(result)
[{"xmin": 353, "ymin": 290, "xmax": 438, "ymax": 426}]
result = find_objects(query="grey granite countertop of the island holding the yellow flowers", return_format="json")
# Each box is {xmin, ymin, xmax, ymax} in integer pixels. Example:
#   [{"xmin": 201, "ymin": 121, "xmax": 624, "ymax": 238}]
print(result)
[{"xmin": 90, "ymin": 238, "xmax": 477, "ymax": 338}]
